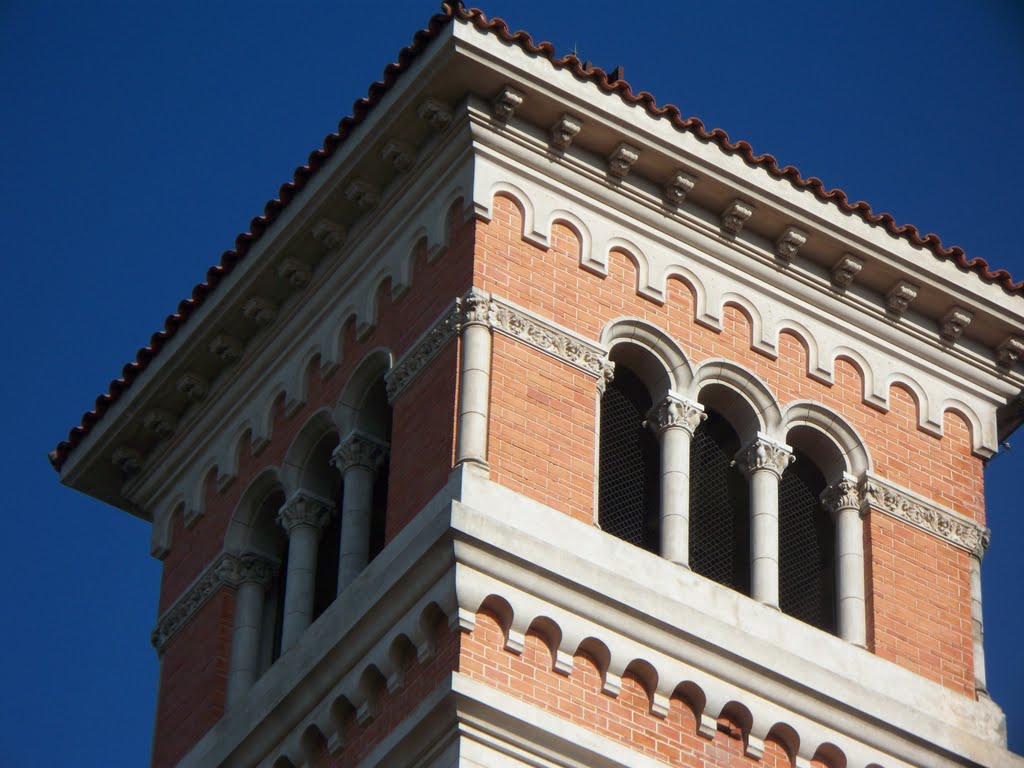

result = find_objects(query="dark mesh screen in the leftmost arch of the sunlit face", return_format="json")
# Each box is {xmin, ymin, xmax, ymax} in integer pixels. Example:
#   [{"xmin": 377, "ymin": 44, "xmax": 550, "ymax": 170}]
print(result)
[{"xmin": 598, "ymin": 365, "xmax": 659, "ymax": 552}]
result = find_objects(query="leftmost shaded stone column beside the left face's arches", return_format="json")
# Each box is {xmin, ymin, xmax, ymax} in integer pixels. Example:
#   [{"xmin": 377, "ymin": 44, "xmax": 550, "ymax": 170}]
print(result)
[{"xmin": 227, "ymin": 553, "xmax": 278, "ymax": 710}]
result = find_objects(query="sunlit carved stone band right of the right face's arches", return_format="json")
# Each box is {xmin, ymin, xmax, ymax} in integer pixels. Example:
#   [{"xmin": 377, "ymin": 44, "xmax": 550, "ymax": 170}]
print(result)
[{"xmin": 860, "ymin": 474, "xmax": 991, "ymax": 559}]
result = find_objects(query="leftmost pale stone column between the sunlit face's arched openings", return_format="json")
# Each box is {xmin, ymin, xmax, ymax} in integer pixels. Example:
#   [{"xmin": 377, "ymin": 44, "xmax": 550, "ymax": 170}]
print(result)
[{"xmin": 647, "ymin": 392, "xmax": 708, "ymax": 568}]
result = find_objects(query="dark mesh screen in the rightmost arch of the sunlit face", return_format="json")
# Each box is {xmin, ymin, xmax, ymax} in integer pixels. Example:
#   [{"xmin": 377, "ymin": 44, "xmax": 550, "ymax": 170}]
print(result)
[{"xmin": 778, "ymin": 451, "xmax": 836, "ymax": 633}]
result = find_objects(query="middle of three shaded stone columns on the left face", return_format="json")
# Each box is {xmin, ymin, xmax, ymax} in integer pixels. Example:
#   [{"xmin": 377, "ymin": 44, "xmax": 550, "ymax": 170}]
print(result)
[{"xmin": 278, "ymin": 490, "xmax": 334, "ymax": 653}]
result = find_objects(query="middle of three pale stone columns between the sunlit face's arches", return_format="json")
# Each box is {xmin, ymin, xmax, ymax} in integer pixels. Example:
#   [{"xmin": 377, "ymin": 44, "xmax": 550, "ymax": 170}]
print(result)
[{"xmin": 736, "ymin": 434, "xmax": 794, "ymax": 608}]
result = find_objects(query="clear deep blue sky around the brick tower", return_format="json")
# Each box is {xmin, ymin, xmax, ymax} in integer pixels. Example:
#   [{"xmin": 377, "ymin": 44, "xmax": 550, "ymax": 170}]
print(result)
[{"xmin": 0, "ymin": 0, "xmax": 1024, "ymax": 768}]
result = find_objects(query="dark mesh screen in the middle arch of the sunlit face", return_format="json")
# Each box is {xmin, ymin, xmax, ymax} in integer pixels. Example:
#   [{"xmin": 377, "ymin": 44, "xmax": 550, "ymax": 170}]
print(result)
[{"xmin": 690, "ymin": 410, "xmax": 751, "ymax": 593}]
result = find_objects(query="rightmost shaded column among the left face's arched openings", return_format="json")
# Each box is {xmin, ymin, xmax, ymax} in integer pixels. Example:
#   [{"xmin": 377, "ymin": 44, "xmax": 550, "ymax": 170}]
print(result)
[{"xmin": 332, "ymin": 432, "xmax": 388, "ymax": 595}]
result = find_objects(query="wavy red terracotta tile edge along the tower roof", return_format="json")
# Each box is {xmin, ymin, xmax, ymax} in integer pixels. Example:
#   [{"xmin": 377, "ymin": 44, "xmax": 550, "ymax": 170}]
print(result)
[{"xmin": 49, "ymin": 0, "xmax": 1024, "ymax": 471}]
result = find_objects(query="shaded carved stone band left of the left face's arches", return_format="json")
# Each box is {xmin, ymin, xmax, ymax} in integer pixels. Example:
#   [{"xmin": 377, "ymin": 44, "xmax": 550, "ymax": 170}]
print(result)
[{"xmin": 150, "ymin": 552, "xmax": 280, "ymax": 655}]
